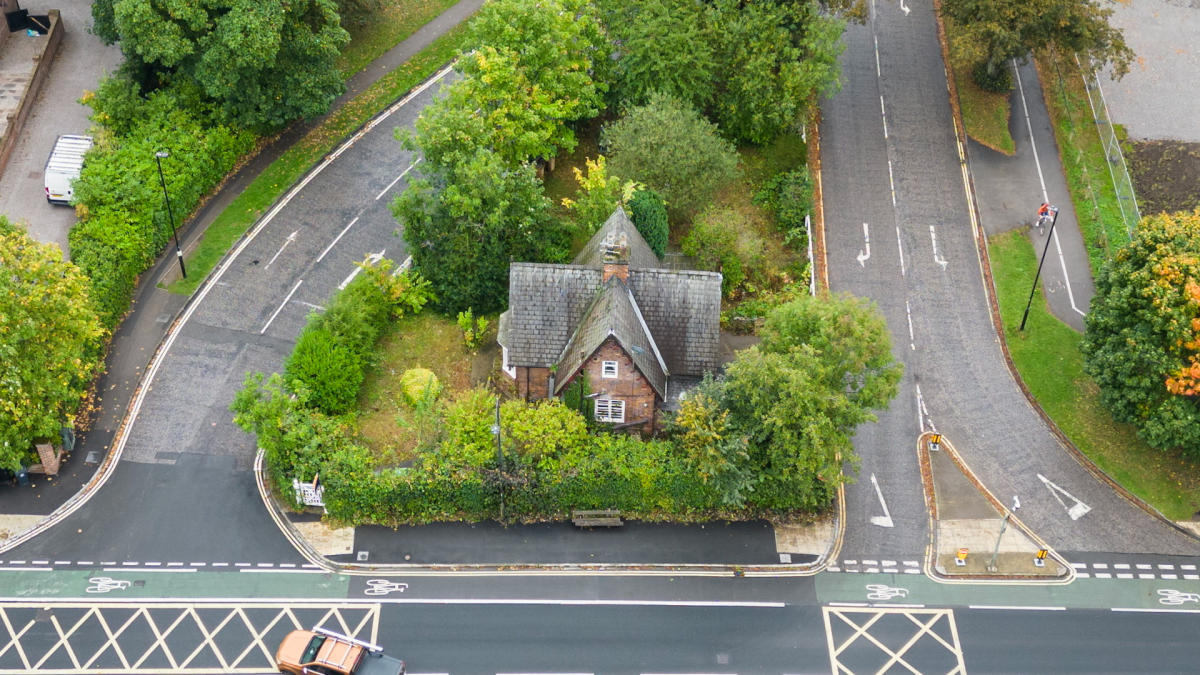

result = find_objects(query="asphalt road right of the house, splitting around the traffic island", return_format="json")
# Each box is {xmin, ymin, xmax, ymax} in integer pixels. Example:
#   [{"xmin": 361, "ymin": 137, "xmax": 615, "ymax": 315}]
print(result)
[{"xmin": 821, "ymin": 1, "xmax": 1200, "ymax": 556}]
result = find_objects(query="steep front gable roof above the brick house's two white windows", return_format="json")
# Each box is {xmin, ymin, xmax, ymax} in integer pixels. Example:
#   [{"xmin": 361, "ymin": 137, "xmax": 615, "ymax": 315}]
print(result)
[{"xmin": 554, "ymin": 276, "xmax": 667, "ymax": 399}]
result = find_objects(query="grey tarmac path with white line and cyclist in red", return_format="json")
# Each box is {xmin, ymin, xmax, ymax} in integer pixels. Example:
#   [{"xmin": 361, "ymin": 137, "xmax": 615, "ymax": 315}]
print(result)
[{"xmin": 967, "ymin": 62, "xmax": 1096, "ymax": 331}]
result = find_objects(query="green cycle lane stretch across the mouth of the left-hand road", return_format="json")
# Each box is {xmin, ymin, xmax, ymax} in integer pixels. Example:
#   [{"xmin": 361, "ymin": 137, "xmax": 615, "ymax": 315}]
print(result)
[{"xmin": 0, "ymin": 568, "xmax": 350, "ymax": 602}]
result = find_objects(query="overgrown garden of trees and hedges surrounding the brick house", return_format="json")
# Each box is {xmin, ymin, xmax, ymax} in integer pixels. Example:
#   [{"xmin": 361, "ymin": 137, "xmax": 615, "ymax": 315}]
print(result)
[{"xmin": 234, "ymin": 0, "xmax": 900, "ymax": 525}]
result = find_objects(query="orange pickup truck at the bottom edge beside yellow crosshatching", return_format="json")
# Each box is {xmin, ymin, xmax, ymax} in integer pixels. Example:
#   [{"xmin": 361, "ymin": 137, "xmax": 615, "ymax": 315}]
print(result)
[{"xmin": 275, "ymin": 627, "xmax": 404, "ymax": 675}]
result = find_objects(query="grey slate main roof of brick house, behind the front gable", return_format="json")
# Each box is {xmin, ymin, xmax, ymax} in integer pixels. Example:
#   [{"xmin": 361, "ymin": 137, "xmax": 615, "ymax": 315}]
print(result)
[{"xmin": 498, "ymin": 209, "xmax": 721, "ymax": 384}]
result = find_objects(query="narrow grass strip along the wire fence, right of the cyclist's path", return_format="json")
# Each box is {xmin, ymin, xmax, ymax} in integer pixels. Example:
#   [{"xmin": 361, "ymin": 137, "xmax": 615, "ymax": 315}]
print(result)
[{"xmin": 1037, "ymin": 53, "xmax": 1129, "ymax": 276}]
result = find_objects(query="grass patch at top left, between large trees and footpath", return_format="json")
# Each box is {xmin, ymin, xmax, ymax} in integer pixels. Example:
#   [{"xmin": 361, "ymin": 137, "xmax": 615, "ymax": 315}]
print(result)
[{"xmin": 337, "ymin": 0, "xmax": 458, "ymax": 77}]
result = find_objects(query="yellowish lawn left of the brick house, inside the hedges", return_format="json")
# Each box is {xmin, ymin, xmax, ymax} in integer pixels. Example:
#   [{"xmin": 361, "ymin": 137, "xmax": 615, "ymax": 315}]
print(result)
[{"xmin": 358, "ymin": 311, "xmax": 497, "ymax": 466}]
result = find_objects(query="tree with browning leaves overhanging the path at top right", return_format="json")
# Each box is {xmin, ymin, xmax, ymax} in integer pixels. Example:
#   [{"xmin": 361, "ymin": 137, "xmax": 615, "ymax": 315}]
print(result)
[{"xmin": 942, "ymin": 0, "xmax": 1134, "ymax": 90}]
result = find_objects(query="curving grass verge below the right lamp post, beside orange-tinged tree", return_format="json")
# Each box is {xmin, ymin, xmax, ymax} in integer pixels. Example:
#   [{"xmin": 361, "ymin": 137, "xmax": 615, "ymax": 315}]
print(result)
[{"xmin": 989, "ymin": 232, "xmax": 1200, "ymax": 520}]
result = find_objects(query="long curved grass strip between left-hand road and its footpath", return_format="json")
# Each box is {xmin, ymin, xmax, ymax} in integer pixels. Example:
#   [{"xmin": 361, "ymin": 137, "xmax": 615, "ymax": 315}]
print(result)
[{"xmin": 168, "ymin": 23, "xmax": 468, "ymax": 295}]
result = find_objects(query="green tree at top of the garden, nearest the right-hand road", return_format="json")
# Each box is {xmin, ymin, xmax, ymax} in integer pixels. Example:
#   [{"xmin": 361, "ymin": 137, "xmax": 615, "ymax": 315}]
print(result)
[{"xmin": 708, "ymin": 0, "xmax": 842, "ymax": 144}]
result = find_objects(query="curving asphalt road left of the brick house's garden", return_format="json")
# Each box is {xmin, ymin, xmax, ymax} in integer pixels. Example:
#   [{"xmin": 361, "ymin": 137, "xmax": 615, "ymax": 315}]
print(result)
[{"xmin": 1, "ymin": 65, "xmax": 451, "ymax": 563}]
